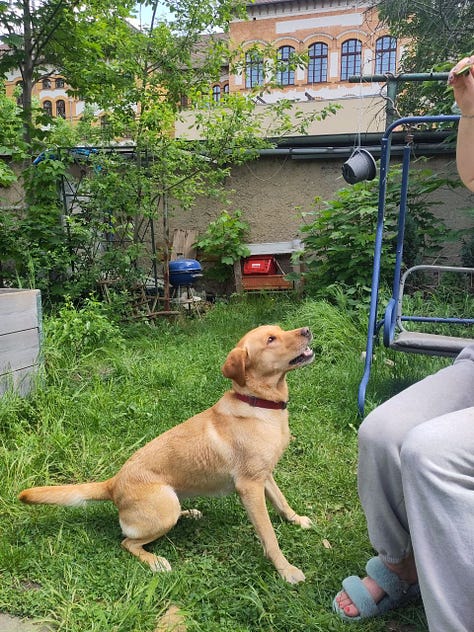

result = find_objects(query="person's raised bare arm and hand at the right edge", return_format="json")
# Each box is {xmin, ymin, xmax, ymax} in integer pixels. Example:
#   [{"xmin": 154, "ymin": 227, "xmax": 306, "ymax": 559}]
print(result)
[{"xmin": 448, "ymin": 55, "xmax": 474, "ymax": 191}]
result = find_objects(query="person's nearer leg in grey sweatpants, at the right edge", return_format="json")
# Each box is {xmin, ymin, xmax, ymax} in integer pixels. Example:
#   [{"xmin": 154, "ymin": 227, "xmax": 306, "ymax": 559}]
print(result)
[{"xmin": 401, "ymin": 408, "xmax": 474, "ymax": 632}]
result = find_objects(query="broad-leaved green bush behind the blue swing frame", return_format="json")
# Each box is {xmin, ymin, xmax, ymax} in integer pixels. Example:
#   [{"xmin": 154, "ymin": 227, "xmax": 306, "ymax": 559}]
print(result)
[{"xmin": 301, "ymin": 159, "xmax": 458, "ymax": 300}]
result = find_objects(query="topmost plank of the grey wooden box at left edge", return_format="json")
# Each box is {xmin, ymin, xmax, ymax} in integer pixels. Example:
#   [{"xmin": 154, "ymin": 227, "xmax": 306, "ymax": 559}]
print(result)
[{"xmin": 0, "ymin": 289, "xmax": 41, "ymax": 335}]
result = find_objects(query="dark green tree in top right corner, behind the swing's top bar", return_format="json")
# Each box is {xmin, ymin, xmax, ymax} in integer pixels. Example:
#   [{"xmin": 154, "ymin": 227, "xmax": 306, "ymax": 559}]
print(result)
[{"xmin": 374, "ymin": 0, "xmax": 474, "ymax": 116}]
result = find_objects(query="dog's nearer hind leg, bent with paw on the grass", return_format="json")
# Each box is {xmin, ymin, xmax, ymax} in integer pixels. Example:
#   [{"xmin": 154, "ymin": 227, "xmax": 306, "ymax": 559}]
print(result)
[{"xmin": 117, "ymin": 483, "xmax": 181, "ymax": 572}]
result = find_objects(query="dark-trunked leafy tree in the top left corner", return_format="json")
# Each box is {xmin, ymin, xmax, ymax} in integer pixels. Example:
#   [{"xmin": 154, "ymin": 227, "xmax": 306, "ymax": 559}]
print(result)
[{"xmin": 0, "ymin": 0, "xmax": 134, "ymax": 145}]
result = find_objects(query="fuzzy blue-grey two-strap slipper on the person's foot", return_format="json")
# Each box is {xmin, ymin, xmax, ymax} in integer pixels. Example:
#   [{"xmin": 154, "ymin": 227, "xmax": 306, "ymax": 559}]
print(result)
[{"xmin": 332, "ymin": 557, "xmax": 420, "ymax": 621}]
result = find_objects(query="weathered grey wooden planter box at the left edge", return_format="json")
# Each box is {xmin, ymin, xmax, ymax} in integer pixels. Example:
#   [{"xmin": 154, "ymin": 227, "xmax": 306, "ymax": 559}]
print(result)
[{"xmin": 0, "ymin": 288, "xmax": 42, "ymax": 396}]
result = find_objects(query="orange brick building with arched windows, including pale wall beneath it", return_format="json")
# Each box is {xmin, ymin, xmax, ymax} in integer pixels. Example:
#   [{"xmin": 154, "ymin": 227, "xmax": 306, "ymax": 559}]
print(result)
[{"xmin": 177, "ymin": 0, "xmax": 403, "ymax": 136}]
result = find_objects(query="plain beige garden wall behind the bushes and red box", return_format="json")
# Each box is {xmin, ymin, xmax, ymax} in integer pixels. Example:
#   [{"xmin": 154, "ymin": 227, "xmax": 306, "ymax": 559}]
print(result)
[{"xmin": 170, "ymin": 157, "xmax": 474, "ymax": 260}]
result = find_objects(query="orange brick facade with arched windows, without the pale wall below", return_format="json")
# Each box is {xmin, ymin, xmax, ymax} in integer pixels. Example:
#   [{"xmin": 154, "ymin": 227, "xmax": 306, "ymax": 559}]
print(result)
[{"xmin": 229, "ymin": 0, "xmax": 402, "ymax": 102}]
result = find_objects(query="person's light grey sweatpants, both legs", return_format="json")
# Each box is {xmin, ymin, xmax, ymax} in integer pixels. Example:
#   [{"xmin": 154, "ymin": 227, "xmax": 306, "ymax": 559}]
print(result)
[{"xmin": 358, "ymin": 345, "xmax": 474, "ymax": 632}]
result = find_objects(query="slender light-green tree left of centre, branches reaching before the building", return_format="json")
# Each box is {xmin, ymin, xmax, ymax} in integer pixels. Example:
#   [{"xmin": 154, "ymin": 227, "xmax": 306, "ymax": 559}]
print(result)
[{"xmin": 64, "ymin": 0, "xmax": 335, "ymax": 308}]
